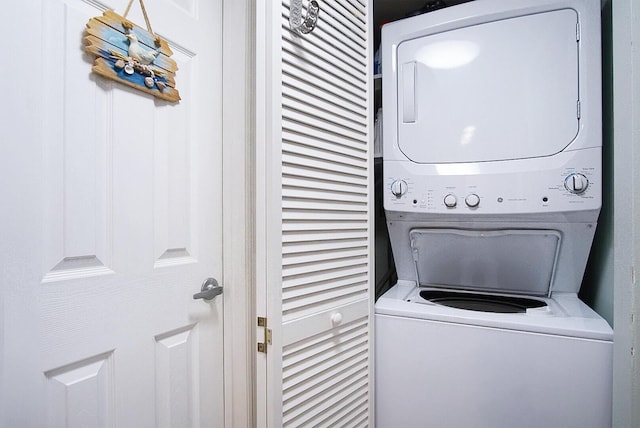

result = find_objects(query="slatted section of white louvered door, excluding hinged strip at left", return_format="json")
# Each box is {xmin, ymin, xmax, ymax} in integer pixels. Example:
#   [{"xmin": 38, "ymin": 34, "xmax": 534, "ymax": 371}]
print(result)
[{"xmin": 281, "ymin": 0, "xmax": 373, "ymax": 427}]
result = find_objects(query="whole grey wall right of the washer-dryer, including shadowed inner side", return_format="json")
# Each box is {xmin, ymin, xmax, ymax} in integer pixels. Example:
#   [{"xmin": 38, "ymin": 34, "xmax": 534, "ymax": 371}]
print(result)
[{"xmin": 581, "ymin": 0, "xmax": 640, "ymax": 427}]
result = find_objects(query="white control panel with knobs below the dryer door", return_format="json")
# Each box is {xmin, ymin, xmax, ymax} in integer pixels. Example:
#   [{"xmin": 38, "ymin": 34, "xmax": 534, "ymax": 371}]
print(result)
[{"xmin": 384, "ymin": 147, "xmax": 602, "ymax": 214}]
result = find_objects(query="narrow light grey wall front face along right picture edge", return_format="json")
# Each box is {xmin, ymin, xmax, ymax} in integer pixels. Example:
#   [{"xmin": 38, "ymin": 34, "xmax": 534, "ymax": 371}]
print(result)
[{"xmin": 602, "ymin": 0, "xmax": 640, "ymax": 427}]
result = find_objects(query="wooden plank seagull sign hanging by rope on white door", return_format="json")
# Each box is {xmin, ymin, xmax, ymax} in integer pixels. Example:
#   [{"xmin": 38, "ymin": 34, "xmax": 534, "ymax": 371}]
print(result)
[{"xmin": 84, "ymin": 0, "xmax": 180, "ymax": 102}]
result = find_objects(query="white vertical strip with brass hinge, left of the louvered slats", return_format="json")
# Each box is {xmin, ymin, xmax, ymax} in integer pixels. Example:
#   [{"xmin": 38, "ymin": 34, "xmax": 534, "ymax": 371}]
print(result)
[{"xmin": 253, "ymin": 0, "xmax": 282, "ymax": 428}]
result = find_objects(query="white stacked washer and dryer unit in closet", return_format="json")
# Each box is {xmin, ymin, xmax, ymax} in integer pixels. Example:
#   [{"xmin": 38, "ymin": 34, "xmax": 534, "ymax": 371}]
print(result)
[{"xmin": 375, "ymin": 0, "xmax": 613, "ymax": 428}]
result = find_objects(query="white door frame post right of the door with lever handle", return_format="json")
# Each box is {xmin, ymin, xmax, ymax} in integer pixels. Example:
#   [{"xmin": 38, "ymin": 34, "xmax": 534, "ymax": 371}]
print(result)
[{"xmin": 222, "ymin": 0, "xmax": 256, "ymax": 427}]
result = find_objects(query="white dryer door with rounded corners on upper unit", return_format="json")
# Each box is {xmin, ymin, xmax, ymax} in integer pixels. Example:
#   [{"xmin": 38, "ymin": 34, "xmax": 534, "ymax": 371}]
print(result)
[{"xmin": 397, "ymin": 9, "xmax": 579, "ymax": 163}]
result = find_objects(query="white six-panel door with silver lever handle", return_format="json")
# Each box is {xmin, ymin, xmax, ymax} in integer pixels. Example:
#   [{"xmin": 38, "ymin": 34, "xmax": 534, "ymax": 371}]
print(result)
[{"xmin": 0, "ymin": 0, "xmax": 224, "ymax": 428}]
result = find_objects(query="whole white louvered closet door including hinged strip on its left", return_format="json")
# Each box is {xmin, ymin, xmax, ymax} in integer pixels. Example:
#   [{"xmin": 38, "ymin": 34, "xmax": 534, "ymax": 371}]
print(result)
[{"xmin": 256, "ymin": 0, "xmax": 374, "ymax": 427}]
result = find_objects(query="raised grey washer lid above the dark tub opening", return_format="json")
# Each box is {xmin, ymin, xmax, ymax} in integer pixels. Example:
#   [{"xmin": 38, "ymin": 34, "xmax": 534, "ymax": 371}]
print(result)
[{"xmin": 409, "ymin": 229, "xmax": 561, "ymax": 296}]
